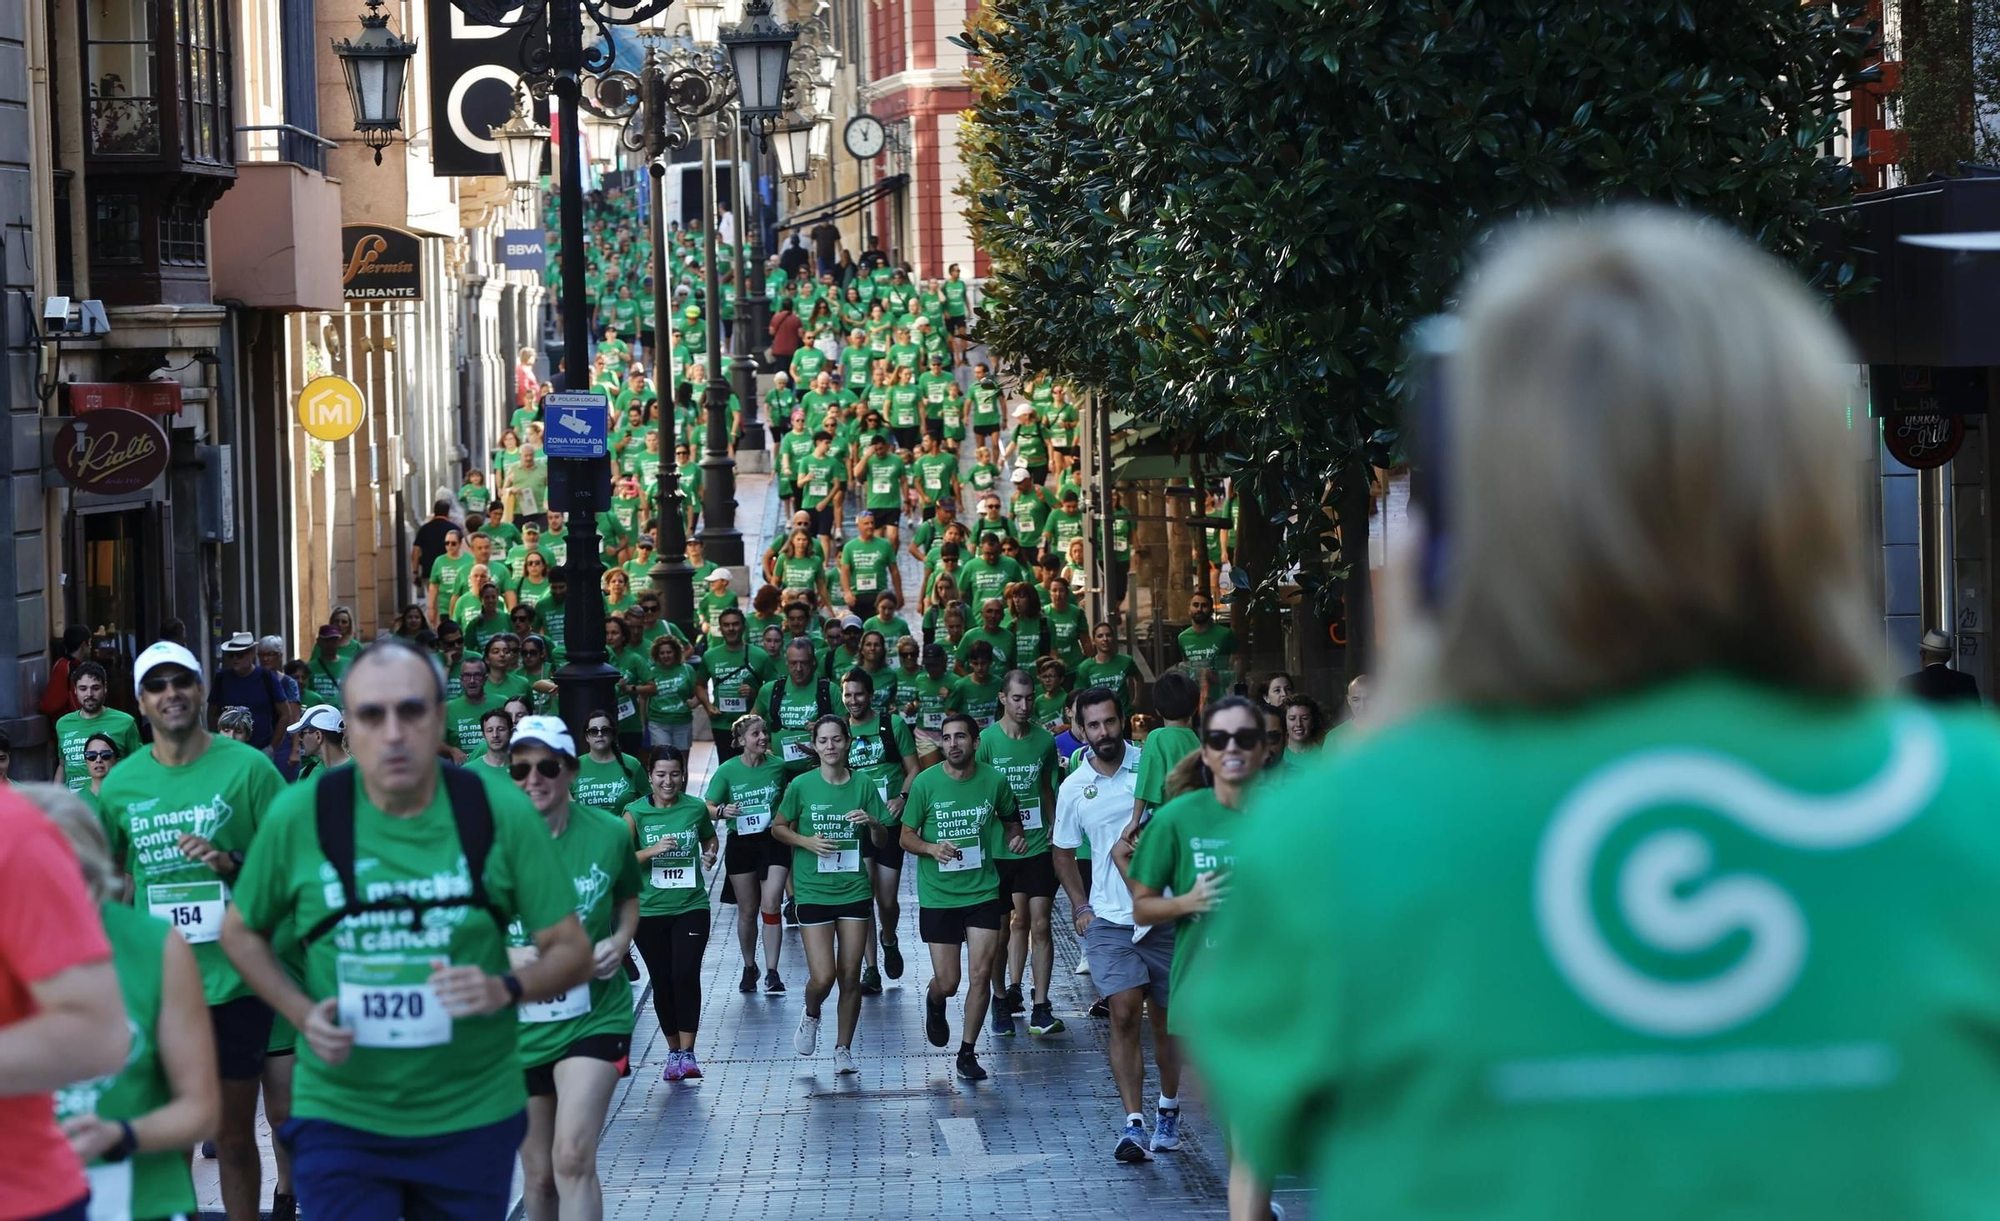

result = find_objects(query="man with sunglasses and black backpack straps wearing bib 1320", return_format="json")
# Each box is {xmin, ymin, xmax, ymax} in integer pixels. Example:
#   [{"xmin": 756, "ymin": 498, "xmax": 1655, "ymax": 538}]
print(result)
[{"xmin": 225, "ymin": 637, "xmax": 592, "ymax": 1221}]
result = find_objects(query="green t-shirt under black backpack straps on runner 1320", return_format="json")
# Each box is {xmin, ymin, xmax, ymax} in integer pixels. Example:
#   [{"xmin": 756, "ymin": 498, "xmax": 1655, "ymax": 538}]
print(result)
[{"xmin": 236, "ymin": 765, "xmax": 576, "ymax": 1137}]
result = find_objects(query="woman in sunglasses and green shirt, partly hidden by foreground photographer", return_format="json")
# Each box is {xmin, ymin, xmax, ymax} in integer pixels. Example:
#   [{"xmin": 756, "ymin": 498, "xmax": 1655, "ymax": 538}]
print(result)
[{"xmin": 1114, "ymin": 695, "xmax": 1270, "ymax": 1219}]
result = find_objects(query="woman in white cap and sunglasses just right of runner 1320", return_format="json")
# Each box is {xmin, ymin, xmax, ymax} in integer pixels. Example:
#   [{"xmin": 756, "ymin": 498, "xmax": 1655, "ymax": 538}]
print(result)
[{"xmin": 508, "ymin": 717, "xmax": 640, "ymax": 1221}]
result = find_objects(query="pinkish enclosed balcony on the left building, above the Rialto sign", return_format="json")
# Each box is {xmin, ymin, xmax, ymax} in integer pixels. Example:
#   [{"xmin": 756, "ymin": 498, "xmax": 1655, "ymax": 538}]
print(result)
[{"xmin": 210, "ymin": 124, "xmax": 342, "ymax": 310}]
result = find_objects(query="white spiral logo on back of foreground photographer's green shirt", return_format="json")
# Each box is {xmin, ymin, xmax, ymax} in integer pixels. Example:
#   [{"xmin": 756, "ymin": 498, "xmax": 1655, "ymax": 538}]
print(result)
[{"xmin": 1534, "ymin": 713, "xmax": 1944, "ymax": 1039}]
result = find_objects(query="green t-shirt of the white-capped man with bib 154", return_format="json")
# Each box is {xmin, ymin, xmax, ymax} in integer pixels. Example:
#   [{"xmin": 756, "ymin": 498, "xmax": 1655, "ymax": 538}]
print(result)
[{"xmin": 98, "ymin": 735, "xmax": 284, "ymax": 1005}]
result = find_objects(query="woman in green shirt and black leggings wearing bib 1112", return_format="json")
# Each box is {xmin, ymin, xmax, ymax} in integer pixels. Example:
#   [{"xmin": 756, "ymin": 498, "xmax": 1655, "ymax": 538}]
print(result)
[{"xmin": 624, "ymin": 747, "xmax": 718, "ymax": 1081}]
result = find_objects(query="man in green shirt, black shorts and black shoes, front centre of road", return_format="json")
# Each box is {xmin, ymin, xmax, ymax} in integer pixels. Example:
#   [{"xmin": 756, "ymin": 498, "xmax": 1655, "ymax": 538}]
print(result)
[{"xmin": 902, "ymin": 713, "xmax": 1028, "ymax": 1081}]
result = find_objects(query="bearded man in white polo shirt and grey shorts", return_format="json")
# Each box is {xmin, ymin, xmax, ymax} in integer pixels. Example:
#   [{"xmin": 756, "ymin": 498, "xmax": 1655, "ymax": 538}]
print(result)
[{"xmin": 1048, "ymin": 687, "xmax": 1180, "ymax": 1161}]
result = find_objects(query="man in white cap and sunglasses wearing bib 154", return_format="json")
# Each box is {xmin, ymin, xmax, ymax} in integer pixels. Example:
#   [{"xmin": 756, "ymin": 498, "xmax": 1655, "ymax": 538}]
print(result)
[{"xmin": 98, "ymin": 639, "xmax": 284, "ymax": 1221}]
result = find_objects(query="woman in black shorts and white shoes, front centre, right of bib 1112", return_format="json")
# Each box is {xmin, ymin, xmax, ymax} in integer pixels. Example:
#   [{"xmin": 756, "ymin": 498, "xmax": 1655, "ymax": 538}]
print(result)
[{"xmin": 770, "ymin": 715, "xmax": 890, "ymax": 1075}]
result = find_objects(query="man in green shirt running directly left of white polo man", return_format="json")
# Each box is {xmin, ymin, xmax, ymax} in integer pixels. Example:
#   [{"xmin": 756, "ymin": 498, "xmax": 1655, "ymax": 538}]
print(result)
[{"xmin": 978, "ymin": 671, "xmax": 1062, "ymax": 1037}]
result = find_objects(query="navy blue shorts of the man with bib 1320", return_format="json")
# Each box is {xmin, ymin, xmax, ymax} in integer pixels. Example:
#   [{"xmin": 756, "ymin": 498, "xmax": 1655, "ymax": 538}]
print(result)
[{"xmin": 278, "ymin": 1111, "xmax": 528, "ymax": 1221}]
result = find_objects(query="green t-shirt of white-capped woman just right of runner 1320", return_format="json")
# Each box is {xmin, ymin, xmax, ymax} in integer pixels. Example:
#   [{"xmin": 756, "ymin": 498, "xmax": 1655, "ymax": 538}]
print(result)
[{"xmin": 506, "ymin": 801, "xmax": 640, "ymax": 1069}]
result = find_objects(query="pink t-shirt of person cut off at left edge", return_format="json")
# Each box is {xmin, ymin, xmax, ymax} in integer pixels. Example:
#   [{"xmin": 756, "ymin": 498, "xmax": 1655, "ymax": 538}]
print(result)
[{"xmin": 0, "ymin": 789, "xmax": 112, "ymax": 1219}]
